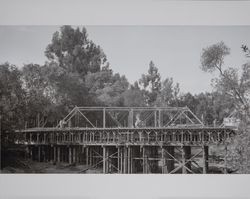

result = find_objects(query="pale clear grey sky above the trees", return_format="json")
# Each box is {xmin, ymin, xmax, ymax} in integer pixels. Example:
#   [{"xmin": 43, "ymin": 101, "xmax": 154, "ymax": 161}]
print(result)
[{"xmin": 0, "ymin": 26, "xmax": 250, "ymax": 94}]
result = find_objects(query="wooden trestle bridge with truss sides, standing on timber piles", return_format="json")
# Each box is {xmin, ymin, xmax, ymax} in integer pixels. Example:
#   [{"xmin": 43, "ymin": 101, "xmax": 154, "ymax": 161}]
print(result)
[{"xmin": 12, "ymin": 107, "xmax": 235, "ymax": 174}]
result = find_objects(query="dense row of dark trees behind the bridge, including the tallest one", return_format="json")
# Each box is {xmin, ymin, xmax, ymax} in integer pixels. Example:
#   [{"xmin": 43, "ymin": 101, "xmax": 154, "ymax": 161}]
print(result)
[{"xmin": 0, "ymin": 26, "xmax": 238, "ymax": 132}]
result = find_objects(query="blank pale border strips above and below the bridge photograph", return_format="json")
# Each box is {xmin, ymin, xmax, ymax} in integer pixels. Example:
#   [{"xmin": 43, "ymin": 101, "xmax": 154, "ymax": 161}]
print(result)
[{"xmin": 0, "ymin": 0, "xmax": 250, "ymax": 199}]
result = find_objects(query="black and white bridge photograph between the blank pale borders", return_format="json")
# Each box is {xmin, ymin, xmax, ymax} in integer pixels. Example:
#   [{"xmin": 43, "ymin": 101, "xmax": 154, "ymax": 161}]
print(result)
[{"xmin": 0, "ymin": 25, "xmax": 250, "ymax": 175}]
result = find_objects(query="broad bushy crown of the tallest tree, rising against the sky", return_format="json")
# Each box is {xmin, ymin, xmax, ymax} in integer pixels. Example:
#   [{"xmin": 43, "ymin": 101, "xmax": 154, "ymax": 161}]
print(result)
[{"xmin": 45, "ymin": 26, "xmax": 108, "ymax": 76}]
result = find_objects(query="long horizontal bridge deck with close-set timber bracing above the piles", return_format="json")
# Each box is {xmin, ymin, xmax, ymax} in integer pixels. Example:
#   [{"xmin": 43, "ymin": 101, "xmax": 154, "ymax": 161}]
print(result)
[{"xmin": 15, "ymin": 126, "xmax": 235, "ymax": 146}]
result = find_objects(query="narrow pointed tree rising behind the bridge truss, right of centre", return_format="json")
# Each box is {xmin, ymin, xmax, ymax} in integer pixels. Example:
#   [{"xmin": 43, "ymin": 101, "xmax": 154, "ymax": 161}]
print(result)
[{"xmin": 139, "ymin": 61, "xmax": 161, "ymax": 105}]
